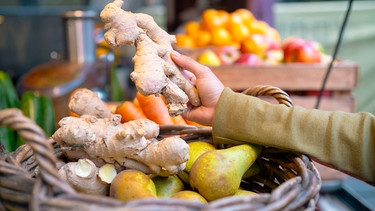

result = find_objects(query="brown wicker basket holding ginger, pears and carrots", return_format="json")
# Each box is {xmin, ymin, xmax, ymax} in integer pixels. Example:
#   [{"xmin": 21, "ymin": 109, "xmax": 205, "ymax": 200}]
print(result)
[{"xmin": 0, "ymin": 86, "xmax": 321, "ymax": 211}]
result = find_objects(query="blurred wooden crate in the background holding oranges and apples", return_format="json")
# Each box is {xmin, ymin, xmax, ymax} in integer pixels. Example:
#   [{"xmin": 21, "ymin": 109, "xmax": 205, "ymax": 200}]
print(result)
[{"xmin": 211, "ymin": 60, "xmax": 359, "ymax": 112}]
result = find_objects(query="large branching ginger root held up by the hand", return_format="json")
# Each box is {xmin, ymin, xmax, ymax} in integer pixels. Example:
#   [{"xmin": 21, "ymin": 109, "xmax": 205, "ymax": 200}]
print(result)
[{"xmin": 100, "ymin": 0, "xmax": 200, "ymax": 116}]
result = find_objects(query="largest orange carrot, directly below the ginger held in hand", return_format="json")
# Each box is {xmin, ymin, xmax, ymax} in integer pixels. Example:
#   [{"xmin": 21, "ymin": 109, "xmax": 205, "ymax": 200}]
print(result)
[{"xmin": 136, "ymin": 92, "xmax": 173, "ymax": 125}]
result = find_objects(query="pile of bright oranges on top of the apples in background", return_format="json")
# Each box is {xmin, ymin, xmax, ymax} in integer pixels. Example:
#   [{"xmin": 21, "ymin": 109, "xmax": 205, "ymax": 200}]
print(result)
[{"xmin": 176, "ymin": 8, "xmax": 280, "ymax": 54}]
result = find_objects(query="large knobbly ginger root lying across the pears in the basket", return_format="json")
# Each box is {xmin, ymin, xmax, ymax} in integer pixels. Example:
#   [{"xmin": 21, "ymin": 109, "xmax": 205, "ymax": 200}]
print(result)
[{"xmin": 52, "ymin": 114, "xmax": 189, "ymax": 176}]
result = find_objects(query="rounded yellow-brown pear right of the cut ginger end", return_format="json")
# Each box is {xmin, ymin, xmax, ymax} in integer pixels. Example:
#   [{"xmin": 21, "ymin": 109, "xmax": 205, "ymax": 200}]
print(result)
[{"xmin": 109, "ymin": 169, "xmax": 157, "ymax": 202}]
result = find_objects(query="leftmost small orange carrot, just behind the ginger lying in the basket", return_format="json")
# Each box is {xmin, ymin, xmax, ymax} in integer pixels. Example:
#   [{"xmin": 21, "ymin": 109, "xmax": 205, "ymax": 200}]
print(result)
[{"xmin": 115, "ymin": 101, "xmax": 146, "ymax": 123}]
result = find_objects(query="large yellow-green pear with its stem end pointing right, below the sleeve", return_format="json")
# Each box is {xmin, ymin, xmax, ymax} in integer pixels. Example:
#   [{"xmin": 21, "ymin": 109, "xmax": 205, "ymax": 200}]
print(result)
[{"xmin": 189, "ymin": 144, "xmax": 262, "ymax": 201}]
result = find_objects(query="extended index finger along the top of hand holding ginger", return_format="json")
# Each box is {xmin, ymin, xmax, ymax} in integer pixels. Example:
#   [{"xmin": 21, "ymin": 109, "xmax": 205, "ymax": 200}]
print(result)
[{"xmin": 171, "ymin": 51, "xmax": 210, "ymax": 78}]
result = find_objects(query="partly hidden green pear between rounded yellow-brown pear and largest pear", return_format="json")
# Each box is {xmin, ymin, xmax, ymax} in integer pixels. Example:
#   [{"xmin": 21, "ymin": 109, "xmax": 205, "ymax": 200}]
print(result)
[{"xmin": 152, "ymin": 175, "xmax": 185, "ymax": 197}]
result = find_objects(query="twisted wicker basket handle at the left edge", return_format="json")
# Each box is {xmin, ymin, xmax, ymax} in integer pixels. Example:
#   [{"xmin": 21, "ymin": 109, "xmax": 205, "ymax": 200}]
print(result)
[{"xmin": 0, "ymin": 108, "xmax": 76, "ymax": 193}]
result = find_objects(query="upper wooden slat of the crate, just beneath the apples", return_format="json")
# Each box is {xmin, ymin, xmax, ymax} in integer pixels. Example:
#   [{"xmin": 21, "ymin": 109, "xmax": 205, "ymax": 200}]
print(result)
[{"xmin": 211, "ymin": 61, "xmax": 359, "ymax": 91}]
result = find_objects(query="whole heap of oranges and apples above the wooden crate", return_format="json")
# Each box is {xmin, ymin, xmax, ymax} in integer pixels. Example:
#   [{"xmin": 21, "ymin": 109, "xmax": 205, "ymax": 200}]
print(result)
[{"xmin": 175, "ymin": 8, "xmax": 326, "ymax": 66}]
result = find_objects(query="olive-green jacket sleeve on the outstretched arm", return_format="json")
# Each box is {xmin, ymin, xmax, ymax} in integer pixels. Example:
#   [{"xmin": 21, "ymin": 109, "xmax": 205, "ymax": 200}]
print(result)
[{"xmin": 212, "ymin": 88, "xmax": 375, "ymax": 183}]
